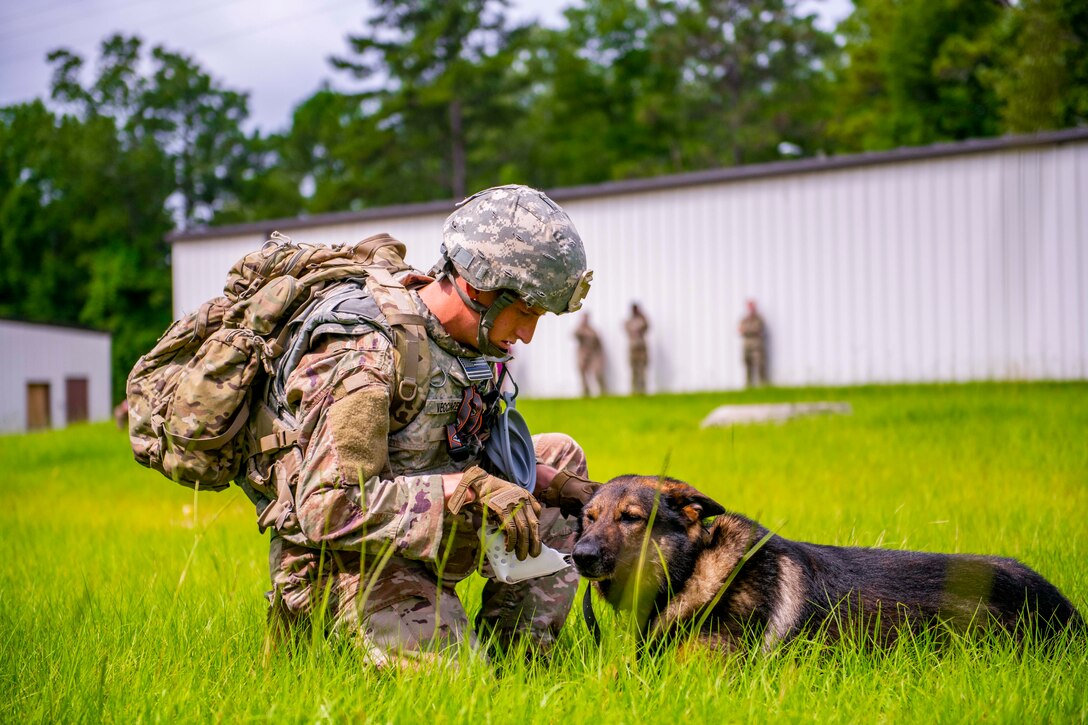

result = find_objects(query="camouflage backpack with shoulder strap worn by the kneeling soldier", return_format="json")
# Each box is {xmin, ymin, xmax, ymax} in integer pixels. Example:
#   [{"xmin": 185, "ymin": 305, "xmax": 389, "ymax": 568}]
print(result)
[{"xmin": 125, "ymin": 232, "xmax": 431, "ymax": 491}]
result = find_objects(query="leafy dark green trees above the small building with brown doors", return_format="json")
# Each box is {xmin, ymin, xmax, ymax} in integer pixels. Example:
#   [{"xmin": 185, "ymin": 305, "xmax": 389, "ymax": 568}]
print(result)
[{"xmin": 0, "ymin": 36, "xmax": 264, "ymax": 397}]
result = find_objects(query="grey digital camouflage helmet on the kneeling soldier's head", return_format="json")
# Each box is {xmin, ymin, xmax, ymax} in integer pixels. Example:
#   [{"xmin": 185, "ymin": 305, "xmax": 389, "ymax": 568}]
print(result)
[{"xmin": 441, "ymin": 184, "xmax": 593, "ymax": 315}]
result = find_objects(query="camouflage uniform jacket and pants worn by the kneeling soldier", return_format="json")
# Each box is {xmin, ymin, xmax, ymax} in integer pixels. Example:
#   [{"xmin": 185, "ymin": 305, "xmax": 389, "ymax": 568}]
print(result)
[{"xmin": 265, "ymin": 275, "xmax": 586, "ymax": 664}]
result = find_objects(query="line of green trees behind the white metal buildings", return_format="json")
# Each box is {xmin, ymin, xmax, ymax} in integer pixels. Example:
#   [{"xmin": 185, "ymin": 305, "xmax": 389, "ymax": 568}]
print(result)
[{"xmin": 0, "ymin": 0, "xmax": 1088, "ymax": 398}]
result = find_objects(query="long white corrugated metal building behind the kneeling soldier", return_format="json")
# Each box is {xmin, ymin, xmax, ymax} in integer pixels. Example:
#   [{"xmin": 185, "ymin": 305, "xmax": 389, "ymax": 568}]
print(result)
[{"xmin": 172, "ymin": 128, "xmax": 1088, "ymax": 397}]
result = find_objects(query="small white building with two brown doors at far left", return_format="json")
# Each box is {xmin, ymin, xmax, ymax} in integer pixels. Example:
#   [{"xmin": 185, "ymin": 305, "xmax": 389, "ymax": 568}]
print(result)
[{"xmin": 0, "ymin": 320, "xmax": 111, "ymax": 433}]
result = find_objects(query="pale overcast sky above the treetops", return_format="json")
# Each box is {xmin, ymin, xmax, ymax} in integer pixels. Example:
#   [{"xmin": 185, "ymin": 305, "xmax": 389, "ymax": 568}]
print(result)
[{"xmin": 0, "ymin": 0, "xmax": 850, "ymax": 132}]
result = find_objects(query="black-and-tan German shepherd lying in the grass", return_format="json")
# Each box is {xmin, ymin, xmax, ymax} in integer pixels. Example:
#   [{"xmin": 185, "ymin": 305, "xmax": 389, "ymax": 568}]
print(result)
[{"xmin": 573, "ymin": 476, "xmax": 1084, "ymax": 650}]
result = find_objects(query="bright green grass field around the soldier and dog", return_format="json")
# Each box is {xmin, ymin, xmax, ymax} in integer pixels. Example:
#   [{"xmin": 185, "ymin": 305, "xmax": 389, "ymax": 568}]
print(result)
[{"xmin": 0, "ymin": 383, "xmax": 1088, "ymax": 723}]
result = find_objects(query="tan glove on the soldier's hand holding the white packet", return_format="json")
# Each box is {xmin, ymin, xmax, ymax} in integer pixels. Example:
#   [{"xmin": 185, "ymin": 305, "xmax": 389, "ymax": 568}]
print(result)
[{"xmin": 446, "ymin": 466, "xmax": 541, "ymax": 561}]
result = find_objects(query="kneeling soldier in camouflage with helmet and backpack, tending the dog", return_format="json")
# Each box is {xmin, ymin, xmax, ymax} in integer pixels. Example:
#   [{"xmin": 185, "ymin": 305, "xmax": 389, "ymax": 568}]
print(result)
[{"xmin": 128, "ymin": 186, "xmax": 595, "ymax": 664}]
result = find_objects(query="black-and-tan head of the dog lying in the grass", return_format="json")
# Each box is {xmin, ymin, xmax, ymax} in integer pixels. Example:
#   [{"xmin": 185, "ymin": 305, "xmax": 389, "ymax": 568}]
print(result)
[{"xmin": 573, "ymin": 476, "xmax": 725, "ymax": 581}]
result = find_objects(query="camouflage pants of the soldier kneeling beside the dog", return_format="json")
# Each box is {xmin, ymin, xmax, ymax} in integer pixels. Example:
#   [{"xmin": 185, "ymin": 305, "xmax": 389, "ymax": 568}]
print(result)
[{"xmin": 269, "ymin": 433, "xmax": 588, "ymax": 665}]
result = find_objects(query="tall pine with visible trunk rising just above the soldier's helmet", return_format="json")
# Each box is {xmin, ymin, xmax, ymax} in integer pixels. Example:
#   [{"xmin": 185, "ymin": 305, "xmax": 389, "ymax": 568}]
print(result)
[{"xmin": 332, "ymin": 0, "xmax": 522, "ymax": 200}]
